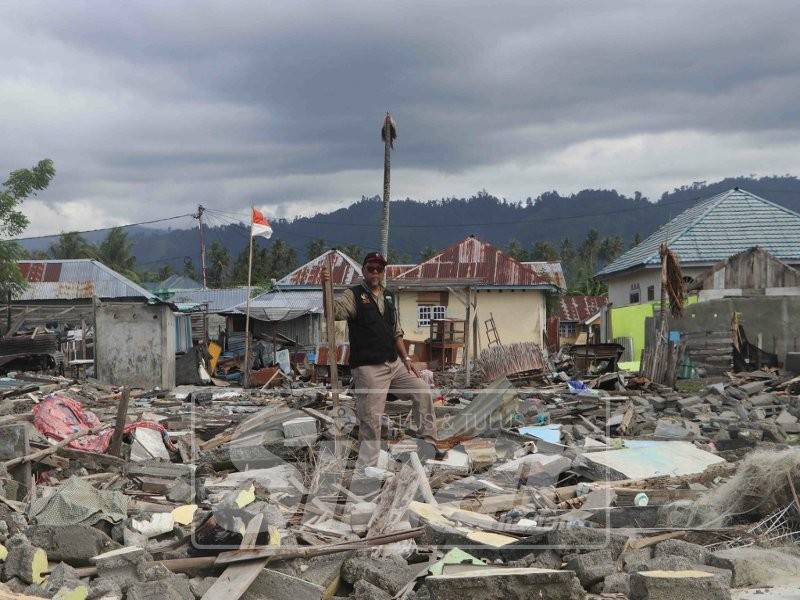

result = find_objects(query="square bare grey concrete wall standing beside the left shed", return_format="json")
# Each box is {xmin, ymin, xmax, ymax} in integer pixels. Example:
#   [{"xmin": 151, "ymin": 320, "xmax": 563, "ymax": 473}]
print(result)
[{"xmin": 96, "ymin": 303, "xmax": 175, "ymax": 389}]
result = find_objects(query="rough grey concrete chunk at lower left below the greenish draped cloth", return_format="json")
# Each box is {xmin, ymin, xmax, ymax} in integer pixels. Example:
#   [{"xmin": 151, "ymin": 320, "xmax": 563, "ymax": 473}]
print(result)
[{"xmin": 27, "ymin": 525, "xmax": 120, "ymax": 567}]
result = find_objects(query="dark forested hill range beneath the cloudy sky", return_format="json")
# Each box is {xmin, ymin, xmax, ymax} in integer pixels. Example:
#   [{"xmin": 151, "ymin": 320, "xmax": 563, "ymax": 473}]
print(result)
[{"xmin": 18, "ymin": 175, "xmax": 800, "ymax": 270}]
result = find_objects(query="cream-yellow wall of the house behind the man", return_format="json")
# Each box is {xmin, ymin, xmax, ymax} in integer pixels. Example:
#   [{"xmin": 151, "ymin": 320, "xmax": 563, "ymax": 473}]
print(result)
[{"xmin": 398, "ymin": 290, "xmax": 546, "ymax": 349}]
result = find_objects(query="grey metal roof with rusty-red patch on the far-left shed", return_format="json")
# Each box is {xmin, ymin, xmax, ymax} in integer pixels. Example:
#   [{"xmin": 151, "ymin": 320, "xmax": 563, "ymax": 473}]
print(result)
[{"xmin": 16, "ymin": 259, "xmax": 156, "ymax": 300}]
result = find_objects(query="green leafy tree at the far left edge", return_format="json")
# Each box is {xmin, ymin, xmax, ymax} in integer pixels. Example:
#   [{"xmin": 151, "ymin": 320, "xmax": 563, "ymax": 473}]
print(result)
[{"xmin": 0, "ymin": 158, "xmax": 56, "ymax": 297}]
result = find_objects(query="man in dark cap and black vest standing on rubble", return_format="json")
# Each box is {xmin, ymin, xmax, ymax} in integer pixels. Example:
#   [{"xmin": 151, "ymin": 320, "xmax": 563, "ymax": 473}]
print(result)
[{"xmin": 326, "ymin": 252, "xmax": 436, "ymax": 466}]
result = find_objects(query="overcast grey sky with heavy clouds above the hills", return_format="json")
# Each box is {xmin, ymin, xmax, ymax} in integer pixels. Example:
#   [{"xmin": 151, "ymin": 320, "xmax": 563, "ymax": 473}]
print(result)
[{"xmin": 0, "ymin": 0, "xmax": 800, "ymax": 235}]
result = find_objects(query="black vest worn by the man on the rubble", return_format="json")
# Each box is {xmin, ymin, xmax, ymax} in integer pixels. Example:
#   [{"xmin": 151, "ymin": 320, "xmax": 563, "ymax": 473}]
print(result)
[{"xmin": 347, "ymin": 285, "xmax": 397, "ymax": 367}]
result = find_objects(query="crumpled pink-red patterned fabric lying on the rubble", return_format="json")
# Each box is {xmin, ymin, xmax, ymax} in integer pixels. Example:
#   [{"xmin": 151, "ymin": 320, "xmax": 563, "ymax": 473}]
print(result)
[{"xmin": 33, "ymin": 394, "xmax": 166, "ymax": 452}]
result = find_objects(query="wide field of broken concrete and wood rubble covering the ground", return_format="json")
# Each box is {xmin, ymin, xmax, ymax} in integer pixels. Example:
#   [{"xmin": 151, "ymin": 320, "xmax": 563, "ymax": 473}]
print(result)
[{"xmin": 0, "ymin": 359, "xmax": 800, "ymax": 600}]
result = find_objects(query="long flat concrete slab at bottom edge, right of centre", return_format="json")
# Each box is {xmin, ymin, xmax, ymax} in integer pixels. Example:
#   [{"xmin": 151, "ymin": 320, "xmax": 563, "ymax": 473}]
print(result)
[{"xmin": 425, "ymin": 567, "xmax": 586, "ymax": 600}]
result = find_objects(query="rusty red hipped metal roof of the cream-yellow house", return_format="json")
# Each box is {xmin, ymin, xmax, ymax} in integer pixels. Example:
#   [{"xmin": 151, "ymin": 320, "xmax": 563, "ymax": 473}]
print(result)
[{"xmin": 395, "ymin": 236, "xmax": 557, "ymax": 287}]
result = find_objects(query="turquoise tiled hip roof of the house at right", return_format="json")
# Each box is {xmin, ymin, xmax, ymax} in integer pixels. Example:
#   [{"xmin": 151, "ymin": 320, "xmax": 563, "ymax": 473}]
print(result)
[{"xmin": 597, "ymin": 188, "xmax": 800, "ymax": 277}]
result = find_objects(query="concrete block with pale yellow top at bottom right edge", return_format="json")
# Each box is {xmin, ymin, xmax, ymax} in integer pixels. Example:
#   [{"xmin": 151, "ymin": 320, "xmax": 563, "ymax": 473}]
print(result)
[{"xmin": 630, "ymin": 571, "xmax": 731, "ymax": 600}]
